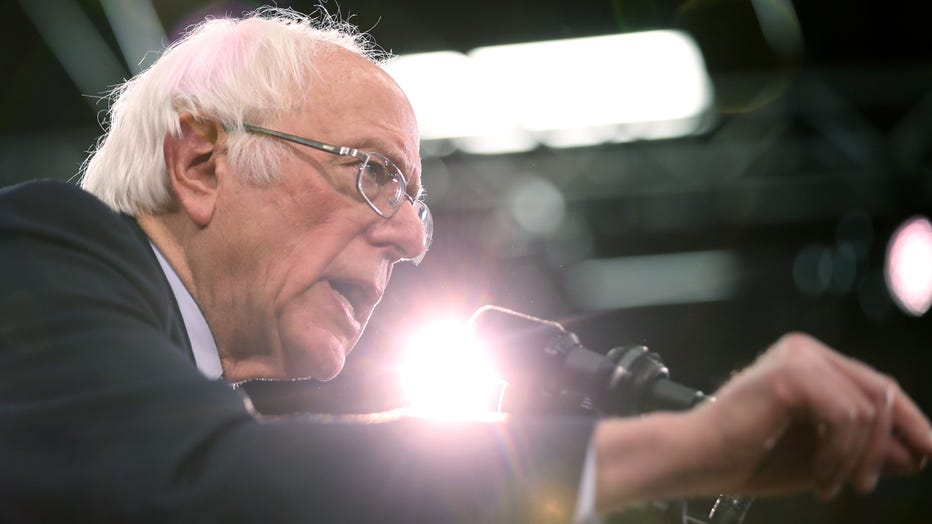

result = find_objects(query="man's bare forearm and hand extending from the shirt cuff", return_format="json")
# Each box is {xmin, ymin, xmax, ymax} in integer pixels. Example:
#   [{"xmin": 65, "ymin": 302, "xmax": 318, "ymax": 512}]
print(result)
[{"xmin": 593, "ymin": 334, "xmax": 932, "ymax": 511}]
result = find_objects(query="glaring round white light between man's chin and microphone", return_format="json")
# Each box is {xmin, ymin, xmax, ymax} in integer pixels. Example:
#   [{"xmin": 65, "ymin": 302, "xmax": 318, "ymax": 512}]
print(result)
[{"xmin": 399, "ymin": 320, "xmax": 502, "ymax": 419}]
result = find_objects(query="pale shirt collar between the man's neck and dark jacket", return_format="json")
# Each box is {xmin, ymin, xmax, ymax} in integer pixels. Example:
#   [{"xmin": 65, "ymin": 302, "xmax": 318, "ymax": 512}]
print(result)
[{"xmin": 149, "ymin": 241, "xmax": 223, "ymax": 380}]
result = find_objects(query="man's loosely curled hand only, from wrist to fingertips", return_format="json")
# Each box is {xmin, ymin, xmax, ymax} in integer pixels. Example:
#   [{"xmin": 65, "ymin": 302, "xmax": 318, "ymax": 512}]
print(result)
[{"xmin": 694, "ymin": 334, "xmax": 932, "ymax": 498}]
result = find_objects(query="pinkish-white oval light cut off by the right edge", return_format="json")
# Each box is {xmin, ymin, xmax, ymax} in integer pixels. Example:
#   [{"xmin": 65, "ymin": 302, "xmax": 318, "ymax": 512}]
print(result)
[{"xmin": 885, "ymin": 217, "xmax": 932, "ymax": 317}]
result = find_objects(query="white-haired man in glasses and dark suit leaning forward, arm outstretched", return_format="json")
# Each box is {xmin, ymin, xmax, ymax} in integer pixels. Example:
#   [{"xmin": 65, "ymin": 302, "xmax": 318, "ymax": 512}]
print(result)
[{"xmin": 0, "ymin": 5, "xmax": 932, "ymax": 522}]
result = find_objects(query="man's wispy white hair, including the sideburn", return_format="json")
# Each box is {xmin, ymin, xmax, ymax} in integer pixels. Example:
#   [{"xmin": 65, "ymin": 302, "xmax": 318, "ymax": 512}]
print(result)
[{"xmin": 81, "ymin": 8, "xmax": 384, "ymax": 215}]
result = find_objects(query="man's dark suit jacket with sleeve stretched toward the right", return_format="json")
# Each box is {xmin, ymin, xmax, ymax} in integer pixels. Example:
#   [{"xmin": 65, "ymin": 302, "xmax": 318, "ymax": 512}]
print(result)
[{"xmin": 0, "ymin": 182, "xmax": 592, "ymax": 523}]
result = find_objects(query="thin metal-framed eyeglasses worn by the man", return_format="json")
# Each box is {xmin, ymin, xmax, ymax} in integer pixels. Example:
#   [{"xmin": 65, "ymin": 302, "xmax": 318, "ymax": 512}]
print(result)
[{"xmin": 243, "ymin": 124, "xmax": 434, "ymax": 265}]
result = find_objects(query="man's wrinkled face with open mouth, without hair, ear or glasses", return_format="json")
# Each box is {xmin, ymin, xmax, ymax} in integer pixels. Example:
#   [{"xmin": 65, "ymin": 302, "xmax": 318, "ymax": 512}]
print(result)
[{"xmin": 202, "ymin": 51, "xmax": 424, "ymax": 381}]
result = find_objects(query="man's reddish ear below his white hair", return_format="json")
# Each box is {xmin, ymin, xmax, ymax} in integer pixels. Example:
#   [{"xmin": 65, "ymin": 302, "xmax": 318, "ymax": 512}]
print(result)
[{"xmin": 163, "ymin": 113, "xmax": 224, "ymax": 227}]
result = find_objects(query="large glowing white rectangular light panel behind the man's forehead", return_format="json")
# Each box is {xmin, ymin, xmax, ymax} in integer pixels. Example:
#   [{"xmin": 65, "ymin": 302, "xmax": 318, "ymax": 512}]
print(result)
[{"xmin": 386, "ymin": 31, "xmax": 712, "ymax": 153}]
